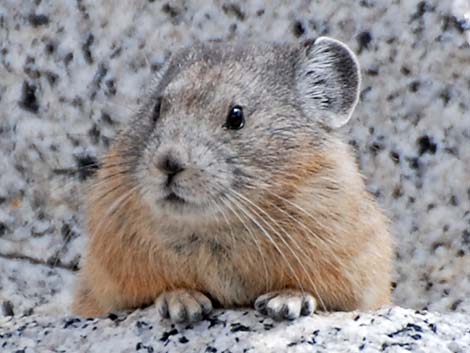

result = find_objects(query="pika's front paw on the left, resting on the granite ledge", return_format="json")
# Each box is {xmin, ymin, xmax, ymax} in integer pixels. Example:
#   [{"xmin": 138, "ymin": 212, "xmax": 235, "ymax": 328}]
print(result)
[{"xmin": 155, "ymin": 289, "xmax": 212, "ymax": 323}]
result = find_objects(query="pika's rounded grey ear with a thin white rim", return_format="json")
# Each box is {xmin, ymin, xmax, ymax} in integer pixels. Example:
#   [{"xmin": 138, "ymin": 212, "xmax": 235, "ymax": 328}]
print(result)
[{"xmin": 296, "ymin": 37, "xmax": 361, "ymax": 128}]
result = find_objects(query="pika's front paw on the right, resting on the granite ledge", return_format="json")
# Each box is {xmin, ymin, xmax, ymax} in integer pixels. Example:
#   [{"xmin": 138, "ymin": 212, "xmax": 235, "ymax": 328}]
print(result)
[{"xmin": 255, "ymin": 290, "xmax": 317, "ymax": 320}]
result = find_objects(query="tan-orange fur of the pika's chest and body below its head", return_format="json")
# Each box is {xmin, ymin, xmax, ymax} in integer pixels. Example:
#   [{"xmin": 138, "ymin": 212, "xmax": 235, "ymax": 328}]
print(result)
[{"xmin": 71, "ymin": 141, "xmax": 391, "ymax": 315}]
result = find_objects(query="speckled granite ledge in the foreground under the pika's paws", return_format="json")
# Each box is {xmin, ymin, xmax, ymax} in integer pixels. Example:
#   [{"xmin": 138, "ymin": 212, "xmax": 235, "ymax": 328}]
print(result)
[{"xmin": 0, "ymin": 308, "xmax": 470, "ymax": 353}]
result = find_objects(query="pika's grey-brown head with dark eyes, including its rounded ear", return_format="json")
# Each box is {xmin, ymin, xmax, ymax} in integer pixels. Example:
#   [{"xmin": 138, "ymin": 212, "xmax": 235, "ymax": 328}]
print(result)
[{"xmin": 129, "ymin": 37, "xmax": 360, "ymax": 221}]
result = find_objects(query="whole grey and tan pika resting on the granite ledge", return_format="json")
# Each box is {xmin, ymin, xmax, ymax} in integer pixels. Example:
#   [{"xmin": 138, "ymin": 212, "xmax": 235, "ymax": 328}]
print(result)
[{"xmin": 73, "ymin": 37, "xmax": 392, "ymax": 322}]
